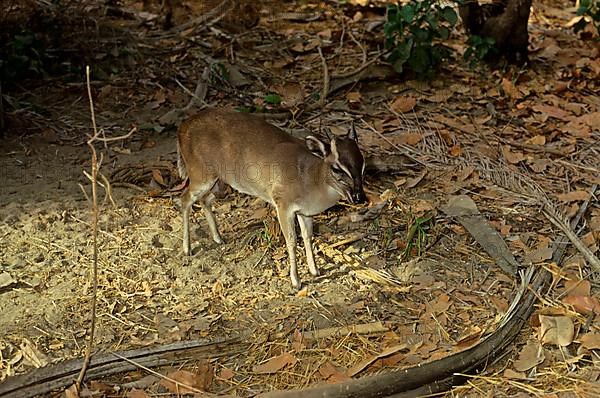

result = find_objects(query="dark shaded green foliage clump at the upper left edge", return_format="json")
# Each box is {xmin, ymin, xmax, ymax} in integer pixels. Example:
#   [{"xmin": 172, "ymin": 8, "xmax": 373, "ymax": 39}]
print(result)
[{"xmin": 0, "ymin": 31, "xmax": 47, "ymax": 81}]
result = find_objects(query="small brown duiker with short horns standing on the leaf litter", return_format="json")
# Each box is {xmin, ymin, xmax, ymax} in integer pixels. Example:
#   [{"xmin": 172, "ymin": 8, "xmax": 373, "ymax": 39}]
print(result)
[{"xmin": 177, "ymin": 109, "xmax": 366, "ymax": 289}]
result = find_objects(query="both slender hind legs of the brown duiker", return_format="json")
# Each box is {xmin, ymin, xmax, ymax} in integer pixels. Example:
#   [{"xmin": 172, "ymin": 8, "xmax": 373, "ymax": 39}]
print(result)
[{"xmin": 181, "ymin": 178, "xmax": 221, "ymax": 256}]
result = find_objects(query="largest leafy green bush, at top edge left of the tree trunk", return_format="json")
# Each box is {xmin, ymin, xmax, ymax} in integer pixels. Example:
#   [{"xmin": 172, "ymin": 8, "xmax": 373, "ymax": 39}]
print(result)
[{"xmin": 384, "ymin": 0, "xmax": 458, "ymax": 78}]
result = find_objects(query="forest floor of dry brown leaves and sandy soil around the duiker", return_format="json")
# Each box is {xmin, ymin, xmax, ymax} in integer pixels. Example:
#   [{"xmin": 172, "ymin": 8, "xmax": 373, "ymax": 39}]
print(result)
[{"xmin": 0, "ymin": 0, "xmax": 600, "ymax": 397}]
